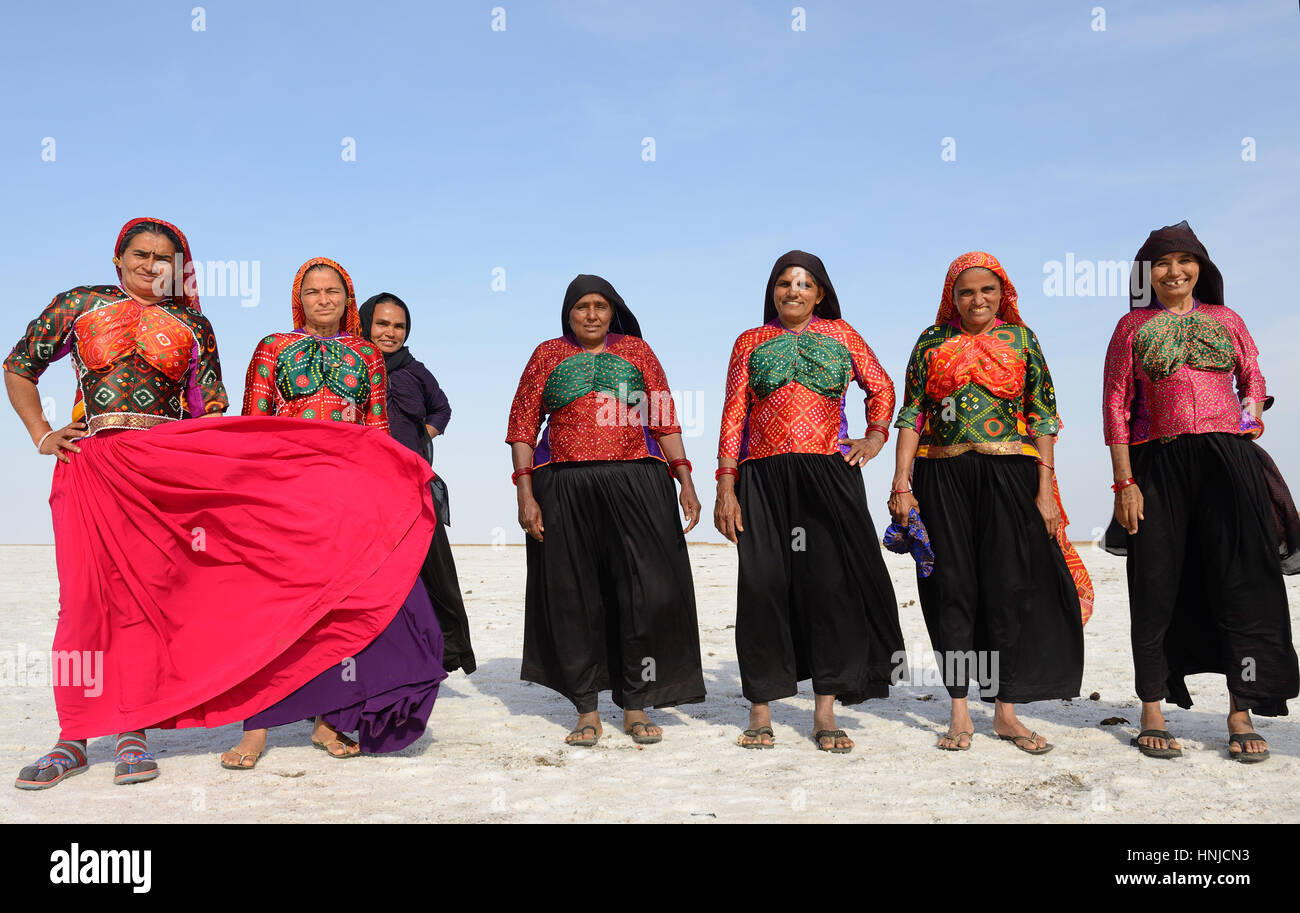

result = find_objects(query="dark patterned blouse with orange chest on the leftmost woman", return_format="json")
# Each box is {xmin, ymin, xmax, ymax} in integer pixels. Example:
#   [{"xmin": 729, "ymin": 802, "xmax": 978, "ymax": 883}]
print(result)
[{"xmin": 4, "ymin": 285, "xmax": 230, "ymax": 434}]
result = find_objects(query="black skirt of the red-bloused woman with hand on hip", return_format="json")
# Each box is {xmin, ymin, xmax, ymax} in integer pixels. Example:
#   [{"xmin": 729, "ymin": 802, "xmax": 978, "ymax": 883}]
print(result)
[{"xmin": 736, "ymin": 454, "xmax": 904, "ymax": 704}]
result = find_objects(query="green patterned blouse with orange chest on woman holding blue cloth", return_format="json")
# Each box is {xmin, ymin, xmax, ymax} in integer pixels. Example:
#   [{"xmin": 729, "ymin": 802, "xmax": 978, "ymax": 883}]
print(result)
[{"xmin": 894, "ymin": 317, "xmax": 1061, "ymax": 459}]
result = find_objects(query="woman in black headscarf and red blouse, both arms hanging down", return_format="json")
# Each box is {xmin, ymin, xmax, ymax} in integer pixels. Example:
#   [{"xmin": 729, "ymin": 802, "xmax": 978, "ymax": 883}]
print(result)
[{"xmin": 506, "ymin": 276, "xmax": 705, "ymax": 747}]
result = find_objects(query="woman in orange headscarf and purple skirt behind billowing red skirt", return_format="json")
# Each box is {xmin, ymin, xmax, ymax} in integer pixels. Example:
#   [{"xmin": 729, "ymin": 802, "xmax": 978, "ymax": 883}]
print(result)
[{"xmin": 221, "ymin": 258, "xmax": 446, "ymax": 770}]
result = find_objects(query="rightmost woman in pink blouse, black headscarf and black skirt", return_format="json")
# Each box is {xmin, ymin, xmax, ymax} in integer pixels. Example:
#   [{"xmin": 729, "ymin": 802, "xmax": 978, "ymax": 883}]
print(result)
[{"xmin": 1104, "ymin": 221, "xmax": 1300, "ymax": 762}]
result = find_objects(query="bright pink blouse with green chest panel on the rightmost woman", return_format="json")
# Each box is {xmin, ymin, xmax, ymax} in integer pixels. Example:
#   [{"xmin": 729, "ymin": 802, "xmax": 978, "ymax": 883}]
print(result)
[{"xmin": 1101, "ymin": 302, "xmax": 1266, "ymax": 443}]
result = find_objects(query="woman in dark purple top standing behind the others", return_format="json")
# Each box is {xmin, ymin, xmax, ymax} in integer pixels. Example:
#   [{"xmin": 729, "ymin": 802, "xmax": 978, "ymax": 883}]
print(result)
[{"xmin": 358, "ymin": 291, "xmax": 477, "ymax": 675}]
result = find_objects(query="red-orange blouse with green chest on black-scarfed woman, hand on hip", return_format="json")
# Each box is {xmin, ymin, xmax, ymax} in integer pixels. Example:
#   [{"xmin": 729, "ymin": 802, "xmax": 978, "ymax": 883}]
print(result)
[{"xmin": 718, "ymin": 317, "xmax": 894, "ymax": 463}]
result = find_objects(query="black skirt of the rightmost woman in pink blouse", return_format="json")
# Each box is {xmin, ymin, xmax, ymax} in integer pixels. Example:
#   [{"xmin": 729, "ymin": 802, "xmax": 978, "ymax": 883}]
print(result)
[{"xmin": 1128, "ymin": 433, "xmax": 1300, "ymax": 717}]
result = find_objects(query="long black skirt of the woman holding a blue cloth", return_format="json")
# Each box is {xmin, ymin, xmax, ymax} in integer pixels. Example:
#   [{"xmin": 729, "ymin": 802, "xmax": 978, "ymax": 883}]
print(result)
[{"xmin": 913, "ymin": 451, "xmax": 1083, "ymax": 704}]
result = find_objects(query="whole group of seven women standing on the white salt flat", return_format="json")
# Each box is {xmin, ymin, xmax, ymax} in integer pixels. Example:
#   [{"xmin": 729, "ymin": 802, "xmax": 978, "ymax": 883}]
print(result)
[{"xmin": 4, "ymin": 218, "xmax": 1300, "ymax": 789}]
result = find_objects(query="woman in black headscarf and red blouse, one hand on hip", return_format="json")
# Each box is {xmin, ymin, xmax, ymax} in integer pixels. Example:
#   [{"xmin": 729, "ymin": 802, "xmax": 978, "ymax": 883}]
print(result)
[{"xmin": 714, "ymin": 251, "xmax": 902, "ymax": 753}]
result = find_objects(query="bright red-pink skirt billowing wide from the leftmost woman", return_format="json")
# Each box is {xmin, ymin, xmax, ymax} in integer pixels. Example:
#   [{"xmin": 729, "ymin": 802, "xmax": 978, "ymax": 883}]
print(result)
[{"xmin": 49, "ymin": 417, "xmax": 436, "ymax": 739}]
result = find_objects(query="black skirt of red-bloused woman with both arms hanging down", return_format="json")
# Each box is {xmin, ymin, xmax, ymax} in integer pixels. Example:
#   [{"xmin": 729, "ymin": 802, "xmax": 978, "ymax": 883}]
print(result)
[{"xmin": 520, "ymin": 459, "xmax": 705, "ymax": 713}]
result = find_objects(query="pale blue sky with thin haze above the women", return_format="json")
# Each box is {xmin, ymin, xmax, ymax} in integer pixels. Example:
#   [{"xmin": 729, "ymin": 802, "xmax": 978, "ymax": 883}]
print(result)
[{"xmin": 0, "ymin": 0, "xmax": 1300, "ymax": 542}]
